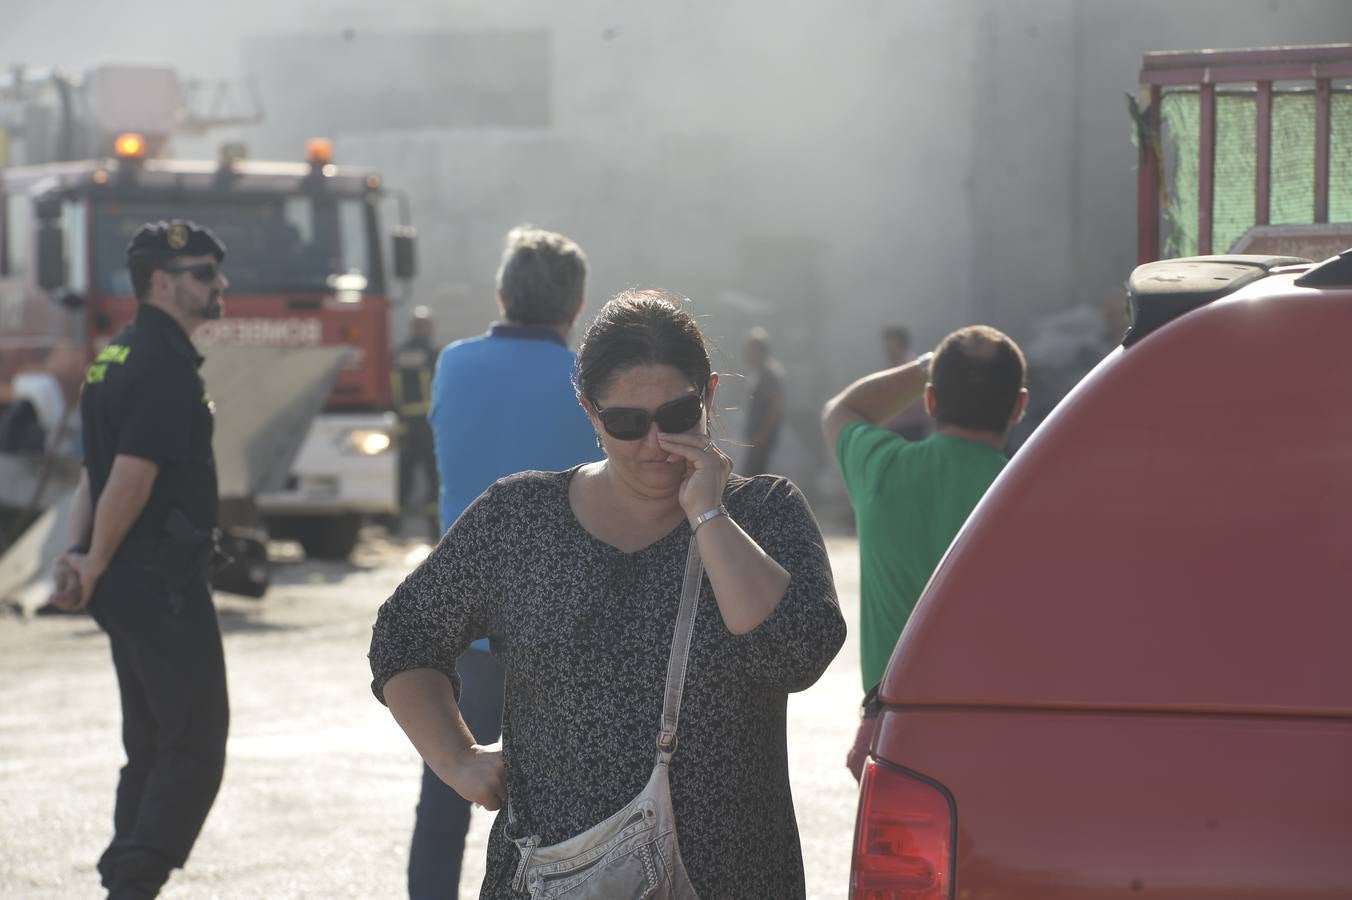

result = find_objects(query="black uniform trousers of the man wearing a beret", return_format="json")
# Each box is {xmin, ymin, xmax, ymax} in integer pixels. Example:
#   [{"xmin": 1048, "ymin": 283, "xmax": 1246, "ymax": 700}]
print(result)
[{"xmin": 91, "ymin": 562, "xmax": 230, "ymax": 900}]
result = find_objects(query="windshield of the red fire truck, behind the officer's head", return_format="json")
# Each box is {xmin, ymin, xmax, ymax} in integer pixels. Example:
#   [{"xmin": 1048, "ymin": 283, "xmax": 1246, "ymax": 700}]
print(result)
[{"xmin": 92, "ymin": 196, "xmax": 383, "ymax": 295}]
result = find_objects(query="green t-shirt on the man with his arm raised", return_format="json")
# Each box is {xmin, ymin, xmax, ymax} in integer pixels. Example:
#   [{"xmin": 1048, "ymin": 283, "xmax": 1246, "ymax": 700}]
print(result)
[{"xmin": 836, "ymin": 422, "xmax": 1007, "ymax": 691}]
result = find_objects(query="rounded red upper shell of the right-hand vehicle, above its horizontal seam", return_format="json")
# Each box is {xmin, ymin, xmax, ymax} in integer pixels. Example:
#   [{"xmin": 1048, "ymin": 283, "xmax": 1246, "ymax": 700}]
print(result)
[{"xmin": 883, "ymin": 270, "xmax": 1352, "ymax": 716}]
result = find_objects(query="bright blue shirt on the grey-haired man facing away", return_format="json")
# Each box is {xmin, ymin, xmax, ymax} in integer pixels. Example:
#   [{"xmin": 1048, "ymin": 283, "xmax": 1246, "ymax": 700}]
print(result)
[{"xmin": 427, "ymin": 323, "xmax": 600, "ymax": 531}]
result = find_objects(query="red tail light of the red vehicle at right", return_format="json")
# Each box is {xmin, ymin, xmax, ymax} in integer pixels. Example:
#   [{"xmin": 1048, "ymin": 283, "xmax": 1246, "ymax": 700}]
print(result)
[{"xmin": 849, "ymin": 759, "xmax": 955, "ymax": 900}]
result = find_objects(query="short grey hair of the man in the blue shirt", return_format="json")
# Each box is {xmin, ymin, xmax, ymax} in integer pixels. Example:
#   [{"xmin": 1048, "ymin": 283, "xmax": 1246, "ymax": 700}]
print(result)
[{"xmin": 498, "ymin": 226, "xmax": 587, "ymax": 326}]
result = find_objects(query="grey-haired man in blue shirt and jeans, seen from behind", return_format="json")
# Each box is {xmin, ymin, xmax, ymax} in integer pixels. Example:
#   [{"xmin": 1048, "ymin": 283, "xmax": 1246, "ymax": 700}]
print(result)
[{"xmin": 408, "ymin": 226, "xmax": 600, "ymax": 900}]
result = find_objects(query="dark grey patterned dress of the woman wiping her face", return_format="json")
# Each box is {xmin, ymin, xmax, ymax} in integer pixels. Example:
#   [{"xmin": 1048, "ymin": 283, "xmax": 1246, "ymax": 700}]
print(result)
[{"xmin": 370, "ymin": 469, "xmax": 845, "ymax": 900}]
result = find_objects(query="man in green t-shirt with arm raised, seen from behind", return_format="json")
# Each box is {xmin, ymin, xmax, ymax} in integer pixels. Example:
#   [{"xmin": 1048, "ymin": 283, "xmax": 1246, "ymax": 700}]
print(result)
[{"xmin": 822, "ymin": 326, "xmax": 1028, "ymax": 778}]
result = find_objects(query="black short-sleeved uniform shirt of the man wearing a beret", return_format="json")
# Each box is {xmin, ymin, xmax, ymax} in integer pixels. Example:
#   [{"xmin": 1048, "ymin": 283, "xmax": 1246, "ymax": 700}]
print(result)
[{"xmin": 80, "ymin": 304, "xmax": 218, "ymax": 559}]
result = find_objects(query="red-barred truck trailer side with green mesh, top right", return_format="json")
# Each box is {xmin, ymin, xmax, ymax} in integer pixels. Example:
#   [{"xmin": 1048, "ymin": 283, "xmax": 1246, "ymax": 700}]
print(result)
[{"xmin": 1134, "ymin": 43, "xmax": 1352, "ymax": 264}]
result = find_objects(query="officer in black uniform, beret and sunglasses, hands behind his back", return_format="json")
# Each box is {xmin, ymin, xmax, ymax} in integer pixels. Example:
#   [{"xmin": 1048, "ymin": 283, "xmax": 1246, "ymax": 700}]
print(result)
[{"xmin": 53, "ymin": 220, "xmax": 230, "ymax": 900}]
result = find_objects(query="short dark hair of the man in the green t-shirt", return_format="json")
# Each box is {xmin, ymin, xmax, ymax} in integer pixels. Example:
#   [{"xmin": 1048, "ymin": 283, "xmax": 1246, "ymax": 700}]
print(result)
[{"xmin": 929, "ymin": 326, "xmax": 1028, "ymax": 434}]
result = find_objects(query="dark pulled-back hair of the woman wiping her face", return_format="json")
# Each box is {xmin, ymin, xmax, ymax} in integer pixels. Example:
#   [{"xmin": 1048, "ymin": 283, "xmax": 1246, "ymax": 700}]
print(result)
[{"xmin": 575, "ymin": 291, "xmax": 713, "ymax": 401}]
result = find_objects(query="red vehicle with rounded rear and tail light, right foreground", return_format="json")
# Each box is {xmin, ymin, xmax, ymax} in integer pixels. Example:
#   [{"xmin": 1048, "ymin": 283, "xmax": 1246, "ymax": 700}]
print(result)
[{"xmin": 850, "ymin": 250, "xmax": 1352, "ymax": 900}]
